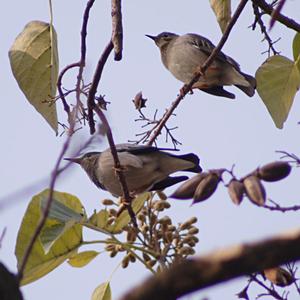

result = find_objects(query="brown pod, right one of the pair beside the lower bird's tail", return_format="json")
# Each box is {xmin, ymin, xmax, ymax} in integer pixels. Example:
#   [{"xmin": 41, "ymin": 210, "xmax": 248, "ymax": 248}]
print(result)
[{"xmin": 193, "ymin": 173, "xmax": 221, "ymax": 204}]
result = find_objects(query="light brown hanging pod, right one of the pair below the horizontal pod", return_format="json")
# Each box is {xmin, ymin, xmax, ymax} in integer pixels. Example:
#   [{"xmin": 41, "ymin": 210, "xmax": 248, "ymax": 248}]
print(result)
[{"xmin": 243, "ymin": 175, "xmax": 266, "ymax": 206}]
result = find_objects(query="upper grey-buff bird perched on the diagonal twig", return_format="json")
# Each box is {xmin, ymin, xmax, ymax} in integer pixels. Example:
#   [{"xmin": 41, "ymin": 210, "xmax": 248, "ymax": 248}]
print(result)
[{"xmin": 146, "ymin": 32, "xmax": 256, "ymax": 99}]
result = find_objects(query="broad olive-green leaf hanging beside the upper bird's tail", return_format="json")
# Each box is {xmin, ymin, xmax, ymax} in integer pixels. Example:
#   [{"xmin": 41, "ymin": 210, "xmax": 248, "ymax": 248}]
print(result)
[{"xmin": 255, "ymin": 55, "xmax": 300, "ymax": 129}]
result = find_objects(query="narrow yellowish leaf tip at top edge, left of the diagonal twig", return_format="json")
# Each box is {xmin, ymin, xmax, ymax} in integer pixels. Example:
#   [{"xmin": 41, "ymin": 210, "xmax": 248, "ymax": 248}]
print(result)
[{"xmin": 209, "ymin": 0, "xmax": 231, "ymax": 33}]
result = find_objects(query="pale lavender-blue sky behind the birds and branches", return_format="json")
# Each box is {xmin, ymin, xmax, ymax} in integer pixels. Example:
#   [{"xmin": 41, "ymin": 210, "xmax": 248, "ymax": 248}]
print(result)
[{"xmin": 0, "ymin": 0, "xmax": 300, "ymax": 300}]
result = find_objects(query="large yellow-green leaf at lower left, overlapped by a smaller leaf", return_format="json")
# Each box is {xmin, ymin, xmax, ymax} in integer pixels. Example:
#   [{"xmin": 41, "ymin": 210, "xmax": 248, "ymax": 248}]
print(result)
[{"xmin": 15, "ymin": 189, "xmax": 82, "ymax": 285}]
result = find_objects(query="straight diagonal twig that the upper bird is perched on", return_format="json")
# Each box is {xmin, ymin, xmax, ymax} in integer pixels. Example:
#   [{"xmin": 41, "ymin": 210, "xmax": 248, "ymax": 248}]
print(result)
[{"xmin": 148, "ymin": 0, "xmax": 248, "ymax": 145}]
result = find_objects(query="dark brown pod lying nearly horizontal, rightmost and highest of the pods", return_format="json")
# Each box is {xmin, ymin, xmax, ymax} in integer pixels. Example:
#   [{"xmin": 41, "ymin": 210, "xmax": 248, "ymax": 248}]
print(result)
[{"xmin": 258, "ymin": 161, "xmax": 292, "ymax": 181}]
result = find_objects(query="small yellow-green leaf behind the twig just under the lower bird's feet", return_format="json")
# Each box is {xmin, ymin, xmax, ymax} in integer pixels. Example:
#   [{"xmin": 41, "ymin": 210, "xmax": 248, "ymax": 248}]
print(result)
[{"xmin": 111, "ymin": 192, "xmax": 151, "ymax": 233}]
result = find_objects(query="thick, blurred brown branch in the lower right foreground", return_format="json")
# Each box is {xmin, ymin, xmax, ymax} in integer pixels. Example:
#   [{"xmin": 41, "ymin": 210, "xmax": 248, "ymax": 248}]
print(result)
[{"xmin": 122, "ymin": 230, "xmax": 300, "ymax": 300}]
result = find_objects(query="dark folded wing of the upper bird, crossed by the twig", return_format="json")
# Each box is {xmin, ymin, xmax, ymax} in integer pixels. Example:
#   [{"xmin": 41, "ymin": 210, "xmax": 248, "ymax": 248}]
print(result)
[{"xmin": 189, "ymin": 33, "xmax": 240, "ymax": 70}]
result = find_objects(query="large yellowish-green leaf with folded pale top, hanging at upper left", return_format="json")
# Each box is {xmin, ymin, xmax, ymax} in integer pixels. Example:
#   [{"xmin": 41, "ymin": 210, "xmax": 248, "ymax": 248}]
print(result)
[{"xmin": 9, "ymin": 21, "xmax": 58, "ymax": 134}]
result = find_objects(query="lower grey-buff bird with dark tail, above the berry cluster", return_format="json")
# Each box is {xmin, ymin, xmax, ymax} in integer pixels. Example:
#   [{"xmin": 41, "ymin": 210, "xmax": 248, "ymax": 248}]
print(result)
[{"xmin": 65, "ymin": 144, "xmax": 202, "ymax": 196}]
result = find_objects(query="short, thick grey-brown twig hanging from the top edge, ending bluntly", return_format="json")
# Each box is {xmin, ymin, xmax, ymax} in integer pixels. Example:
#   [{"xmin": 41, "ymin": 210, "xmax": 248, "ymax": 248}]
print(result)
[{"xmin": 111, "ymin": 0, "xmax": 123, "ymax": 60}]
